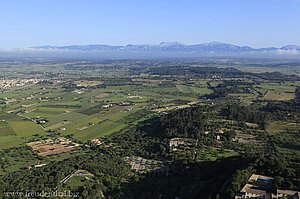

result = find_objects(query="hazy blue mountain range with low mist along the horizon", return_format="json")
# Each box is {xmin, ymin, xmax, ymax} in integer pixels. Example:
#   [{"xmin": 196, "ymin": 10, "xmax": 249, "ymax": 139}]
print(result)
[{"xmin": 0, "ymin": 42, "xmax": 300, "ymax": 59}]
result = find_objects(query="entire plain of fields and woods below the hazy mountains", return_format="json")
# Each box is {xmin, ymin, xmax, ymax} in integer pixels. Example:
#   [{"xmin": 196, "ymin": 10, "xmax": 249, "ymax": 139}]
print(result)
[{"xmin": 0, "ymin": 60, "xmax": 300, "ymax": 198}]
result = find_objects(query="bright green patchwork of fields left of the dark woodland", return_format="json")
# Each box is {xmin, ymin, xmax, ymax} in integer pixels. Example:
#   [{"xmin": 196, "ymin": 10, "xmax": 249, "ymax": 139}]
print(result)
[{"xmin": 0, "ymin": 64, "xmax": 219, "ymax": 148}]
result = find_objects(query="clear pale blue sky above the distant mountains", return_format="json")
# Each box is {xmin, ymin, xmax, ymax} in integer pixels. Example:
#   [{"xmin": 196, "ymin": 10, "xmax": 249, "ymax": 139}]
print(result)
[{"xmin": 0, "ymin": 0, "xmax": 300, "ymax": 49}]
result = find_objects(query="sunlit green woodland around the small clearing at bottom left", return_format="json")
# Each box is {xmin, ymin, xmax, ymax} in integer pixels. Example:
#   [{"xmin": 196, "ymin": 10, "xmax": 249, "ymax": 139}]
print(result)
[{"xmin": 0, "ymin": 151, "xmax": 130, "ymax": 198}]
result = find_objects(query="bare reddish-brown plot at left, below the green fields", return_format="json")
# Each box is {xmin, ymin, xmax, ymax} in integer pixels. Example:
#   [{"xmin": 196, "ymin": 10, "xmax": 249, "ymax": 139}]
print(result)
[{"xmin": 27, "ymin": 138, "xmax": 80, "ymax": 156}]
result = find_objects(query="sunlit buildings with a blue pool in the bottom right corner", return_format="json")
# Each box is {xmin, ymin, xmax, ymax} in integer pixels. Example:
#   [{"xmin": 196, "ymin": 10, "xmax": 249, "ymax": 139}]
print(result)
[{"xmin": 235, "ymin": 174, "xmax": 300, "ymax": 199}]
